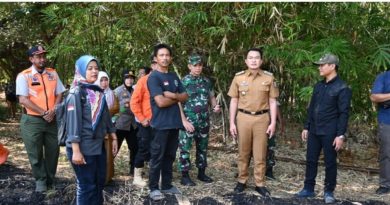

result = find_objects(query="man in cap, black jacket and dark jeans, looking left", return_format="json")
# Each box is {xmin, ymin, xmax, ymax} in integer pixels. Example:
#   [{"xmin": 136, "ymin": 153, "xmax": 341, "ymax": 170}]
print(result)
[{"xmin": 296, "ymin": 54, "xmax": 352, "ymax": 203}]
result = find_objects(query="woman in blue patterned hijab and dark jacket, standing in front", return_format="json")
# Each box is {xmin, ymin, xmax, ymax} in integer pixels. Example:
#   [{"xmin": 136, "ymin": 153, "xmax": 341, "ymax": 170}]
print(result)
[{"xmin": 66, "ymin": 55, "xmax": 118, "ymax": 205}]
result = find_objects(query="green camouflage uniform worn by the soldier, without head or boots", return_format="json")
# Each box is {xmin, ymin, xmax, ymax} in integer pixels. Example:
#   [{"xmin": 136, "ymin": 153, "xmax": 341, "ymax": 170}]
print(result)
[{"xmin": 178, "ymin": 74, "xmax": 214, "ymax": 172}]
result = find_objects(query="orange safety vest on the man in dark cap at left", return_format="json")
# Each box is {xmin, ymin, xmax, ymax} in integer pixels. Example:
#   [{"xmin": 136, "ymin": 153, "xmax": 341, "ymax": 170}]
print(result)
[{"xmin": 20, "ymin": 68, "xmax": 58, "ymax": 115}]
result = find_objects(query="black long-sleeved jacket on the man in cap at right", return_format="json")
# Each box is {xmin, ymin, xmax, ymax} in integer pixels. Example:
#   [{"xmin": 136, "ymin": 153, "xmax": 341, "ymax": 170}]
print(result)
[{"xmin": 304, "ymin": 76, "xmax": 352, "ymax": 137}]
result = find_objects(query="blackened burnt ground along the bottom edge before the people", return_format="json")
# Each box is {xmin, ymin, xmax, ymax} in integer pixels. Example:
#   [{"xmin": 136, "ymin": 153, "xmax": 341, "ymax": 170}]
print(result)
[{"xmin": 0, "ymin": 163, "xmax": 386, "ymax": 205}]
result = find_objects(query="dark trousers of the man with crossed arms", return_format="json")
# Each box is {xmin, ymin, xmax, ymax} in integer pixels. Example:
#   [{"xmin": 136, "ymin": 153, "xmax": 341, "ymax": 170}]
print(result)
[{"xmin": 149, "ymin": 129, "xmax": 179, "ymax": 191}]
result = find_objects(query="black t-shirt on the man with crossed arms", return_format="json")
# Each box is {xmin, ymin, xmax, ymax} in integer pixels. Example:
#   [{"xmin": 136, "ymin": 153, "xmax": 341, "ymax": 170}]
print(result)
[{"xmin": 147, "ymin": 71, "xmax": 185, "ymax": 130}]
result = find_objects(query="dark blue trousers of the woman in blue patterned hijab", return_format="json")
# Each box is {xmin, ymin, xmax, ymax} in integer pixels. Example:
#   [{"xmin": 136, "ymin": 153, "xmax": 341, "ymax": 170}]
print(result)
[{"xmin": 66, "ymin": 146, "xmax": 106, "ymax": 205}]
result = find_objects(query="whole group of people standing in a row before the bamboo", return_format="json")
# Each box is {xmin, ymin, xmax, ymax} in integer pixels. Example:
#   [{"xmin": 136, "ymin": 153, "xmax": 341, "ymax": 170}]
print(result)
[{"xmin": 16, "ymin": 44, "xmax": 390, "ymax": 204}]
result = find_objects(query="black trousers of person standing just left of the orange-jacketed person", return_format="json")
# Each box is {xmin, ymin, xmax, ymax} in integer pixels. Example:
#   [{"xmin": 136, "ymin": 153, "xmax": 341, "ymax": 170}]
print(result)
[{"xmin": 116, "ymin": 127, "xmax": 138, "ymax": 174}]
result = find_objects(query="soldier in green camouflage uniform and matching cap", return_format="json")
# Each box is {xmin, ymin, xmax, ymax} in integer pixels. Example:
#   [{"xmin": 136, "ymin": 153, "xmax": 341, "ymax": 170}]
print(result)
[{"xmin": 178, "ymin": 54, "xmax": 220, "ymax": 186}]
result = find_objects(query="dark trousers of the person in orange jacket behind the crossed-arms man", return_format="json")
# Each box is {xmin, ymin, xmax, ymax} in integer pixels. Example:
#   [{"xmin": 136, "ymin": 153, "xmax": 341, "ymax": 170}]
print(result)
[{"xmin": 134, "ymin": 123, "xmax": 153, "ymax": 168}]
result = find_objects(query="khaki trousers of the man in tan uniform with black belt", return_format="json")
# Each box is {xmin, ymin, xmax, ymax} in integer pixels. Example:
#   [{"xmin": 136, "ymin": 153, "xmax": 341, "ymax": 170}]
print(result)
[{"xmin": 237, "ymin": 112, "xmax": 270, "ymax": 187}]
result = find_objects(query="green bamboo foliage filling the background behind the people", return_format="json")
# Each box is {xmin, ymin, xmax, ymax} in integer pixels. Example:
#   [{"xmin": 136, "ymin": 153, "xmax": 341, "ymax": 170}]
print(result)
[{"xmin": 0, "ymin": 2, "xmax": 390, "ymax": 125}]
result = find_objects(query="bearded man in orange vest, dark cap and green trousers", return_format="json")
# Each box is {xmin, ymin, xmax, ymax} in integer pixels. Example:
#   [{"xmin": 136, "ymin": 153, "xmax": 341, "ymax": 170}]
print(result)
[{"xmin": 16, "ymin": 46, "xmax": 65, "ymax": 192}]
